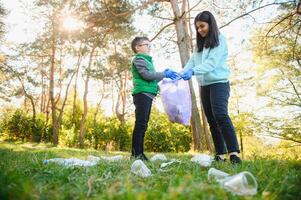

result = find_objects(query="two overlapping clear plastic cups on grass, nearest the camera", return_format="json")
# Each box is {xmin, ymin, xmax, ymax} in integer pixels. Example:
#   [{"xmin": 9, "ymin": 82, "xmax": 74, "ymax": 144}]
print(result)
[{"xmin": 208, "ymin": 168, "xmax": 258, "ymax": 195}]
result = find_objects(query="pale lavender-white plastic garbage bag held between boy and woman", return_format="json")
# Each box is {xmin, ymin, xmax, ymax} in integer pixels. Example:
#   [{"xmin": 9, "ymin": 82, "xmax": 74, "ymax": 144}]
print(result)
[{"xmin": 159, "ymin": 78, "xmax": 191, "ymax": 126}]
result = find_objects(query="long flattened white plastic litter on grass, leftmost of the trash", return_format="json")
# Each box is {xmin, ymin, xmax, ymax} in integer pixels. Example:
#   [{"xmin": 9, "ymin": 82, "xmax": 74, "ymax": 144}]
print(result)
[{"xmin": 43, "ymin": 158, "xmax": 97, "ymax": 167}]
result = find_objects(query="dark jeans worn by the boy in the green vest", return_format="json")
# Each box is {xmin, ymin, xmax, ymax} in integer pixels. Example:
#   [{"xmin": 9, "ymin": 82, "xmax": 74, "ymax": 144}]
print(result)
[{"xmin": 132, "ymin": 93, "xmax": 153, "ymax": 156}]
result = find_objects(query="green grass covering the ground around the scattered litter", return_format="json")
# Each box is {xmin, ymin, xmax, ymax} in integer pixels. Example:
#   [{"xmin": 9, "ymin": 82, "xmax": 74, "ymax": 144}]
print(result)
[{"xmin": 0, "ymin": 142, "xmax": 301, "ymax": 200}]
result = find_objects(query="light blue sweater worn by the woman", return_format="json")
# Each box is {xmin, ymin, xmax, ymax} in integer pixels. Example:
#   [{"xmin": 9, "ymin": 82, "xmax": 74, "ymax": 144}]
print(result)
[{"xmin": 183, "ymin": 34, "xmax": 230, "ymax": 86}]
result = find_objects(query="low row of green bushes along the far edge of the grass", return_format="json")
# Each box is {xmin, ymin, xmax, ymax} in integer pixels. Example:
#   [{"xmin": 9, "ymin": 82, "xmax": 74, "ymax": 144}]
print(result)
[{"xmin": 0, "ymin": 103, "xmax": 192, "ymax": 152}]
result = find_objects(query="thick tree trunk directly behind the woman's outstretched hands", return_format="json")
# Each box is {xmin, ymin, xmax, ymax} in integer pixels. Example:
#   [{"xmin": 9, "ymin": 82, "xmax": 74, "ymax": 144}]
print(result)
[{"xmin": 170, "ymin": 0, "xmax": 202, "ymax": 151}]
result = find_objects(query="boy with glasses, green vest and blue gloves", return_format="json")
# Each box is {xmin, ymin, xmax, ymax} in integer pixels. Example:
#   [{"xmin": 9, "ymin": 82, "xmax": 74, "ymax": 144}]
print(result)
[{"xmin": 131, "ymin": 37, "xmax": 179, "ymax": 160}]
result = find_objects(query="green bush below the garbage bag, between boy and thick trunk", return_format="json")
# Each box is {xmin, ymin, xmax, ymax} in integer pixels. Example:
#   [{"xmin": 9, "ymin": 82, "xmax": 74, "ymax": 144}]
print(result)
[{"xmin": 145, "ymin": 109, "xmax": 192, "ymax": 152}]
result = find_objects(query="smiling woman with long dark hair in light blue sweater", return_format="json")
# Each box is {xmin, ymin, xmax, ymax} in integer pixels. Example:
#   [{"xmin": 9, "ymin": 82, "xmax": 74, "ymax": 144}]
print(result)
[{"xmin": 181, "ymin": 11, "xmax": 241, "ymax": 164}]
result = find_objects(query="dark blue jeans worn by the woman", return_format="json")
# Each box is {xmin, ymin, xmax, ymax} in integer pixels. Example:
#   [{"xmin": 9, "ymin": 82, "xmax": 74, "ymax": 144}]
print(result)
[{"xmin": 200, "ymin": 82, "xmax": 240, "ymax": 155}]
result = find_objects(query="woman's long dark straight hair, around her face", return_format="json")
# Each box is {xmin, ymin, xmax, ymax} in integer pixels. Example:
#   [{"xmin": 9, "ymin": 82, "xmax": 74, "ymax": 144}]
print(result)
[{"xmin": 194, "ymin": 11, "xmax": 219, "ymax": 52}]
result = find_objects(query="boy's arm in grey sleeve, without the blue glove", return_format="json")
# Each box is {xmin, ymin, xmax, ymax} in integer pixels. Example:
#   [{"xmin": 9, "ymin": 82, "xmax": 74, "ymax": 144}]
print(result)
[{"xmin": 133, "ymin": 58, "xmax": 165, "ymax": 81}]
